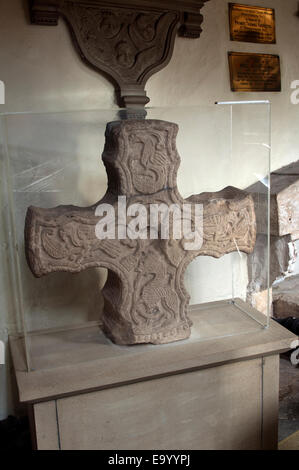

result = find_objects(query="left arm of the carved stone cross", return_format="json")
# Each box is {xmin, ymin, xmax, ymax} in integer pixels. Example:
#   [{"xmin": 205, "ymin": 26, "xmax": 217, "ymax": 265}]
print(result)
[{"xmin": 25, "ymin": 200, "xmax": 138, "ymax": 277}]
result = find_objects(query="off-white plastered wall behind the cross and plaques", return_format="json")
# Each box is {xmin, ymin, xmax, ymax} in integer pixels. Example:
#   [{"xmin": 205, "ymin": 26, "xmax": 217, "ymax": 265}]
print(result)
[{"xmin": 0, "ymin": 0, "xmax": 299, "ymax": 419}]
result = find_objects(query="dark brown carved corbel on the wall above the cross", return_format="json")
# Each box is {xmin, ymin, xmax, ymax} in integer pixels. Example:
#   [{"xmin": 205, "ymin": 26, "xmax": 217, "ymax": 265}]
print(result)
[{"xmin": 30, "ymin": 0, "xmax": 209, "ymax": 109}]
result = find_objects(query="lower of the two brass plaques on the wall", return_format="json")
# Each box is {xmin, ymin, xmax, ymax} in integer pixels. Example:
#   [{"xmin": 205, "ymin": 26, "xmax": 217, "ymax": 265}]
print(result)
[{"xmin": 228, "ymin": 52, "xmax": 281, "ymax": 91}]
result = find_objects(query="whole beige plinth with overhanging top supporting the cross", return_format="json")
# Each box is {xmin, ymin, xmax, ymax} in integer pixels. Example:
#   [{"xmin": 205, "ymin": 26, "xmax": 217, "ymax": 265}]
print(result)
[{"xmin": 10, "ymin": 301, "xmax": 298, "ymax": 450}]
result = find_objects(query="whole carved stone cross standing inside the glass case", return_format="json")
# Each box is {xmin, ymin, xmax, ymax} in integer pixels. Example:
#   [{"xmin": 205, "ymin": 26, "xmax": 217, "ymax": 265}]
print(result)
[{"xmin": 25, "ymin": 120, "xmax": 256, "ymax": 344}]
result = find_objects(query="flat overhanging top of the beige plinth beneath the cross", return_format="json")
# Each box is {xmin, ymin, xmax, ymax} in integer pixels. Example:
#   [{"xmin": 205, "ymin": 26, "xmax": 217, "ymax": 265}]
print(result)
[{"xmin": 10, "ymin": 299, "xmax": 299, "ymax": 403}]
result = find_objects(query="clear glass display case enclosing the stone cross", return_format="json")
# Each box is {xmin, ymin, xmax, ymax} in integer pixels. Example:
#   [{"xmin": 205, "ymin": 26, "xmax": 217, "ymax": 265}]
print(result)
[{"xmin": 0, "ymin": 101, "xmax": 271, "ymax": 371}]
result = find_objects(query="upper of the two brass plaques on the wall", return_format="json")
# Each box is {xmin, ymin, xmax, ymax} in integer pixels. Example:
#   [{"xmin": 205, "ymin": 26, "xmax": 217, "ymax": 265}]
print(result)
[{"xmin": 229, "ymin": 3, "xmax": 276, "ymax": 44}]
